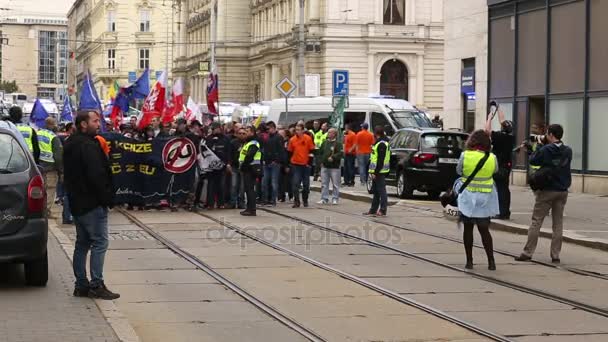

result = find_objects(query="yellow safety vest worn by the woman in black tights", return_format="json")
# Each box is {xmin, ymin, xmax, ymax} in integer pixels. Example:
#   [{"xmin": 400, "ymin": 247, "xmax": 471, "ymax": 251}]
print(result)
[{"xmin": 462, "ymin": 151, "xmax": 496, "ymax": 192}]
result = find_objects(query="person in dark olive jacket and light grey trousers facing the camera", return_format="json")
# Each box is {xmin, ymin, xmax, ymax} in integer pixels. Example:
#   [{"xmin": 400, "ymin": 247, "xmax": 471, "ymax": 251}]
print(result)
[{"xmin": 318, "ymin": 128, "xmax": 344, "ymax": 205}]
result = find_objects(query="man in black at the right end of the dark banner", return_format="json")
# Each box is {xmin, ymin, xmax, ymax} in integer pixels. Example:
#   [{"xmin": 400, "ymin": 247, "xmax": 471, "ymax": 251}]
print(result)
[{"xmin": 206, "ymin": 122, "xmax": 232, "ymax": 210}]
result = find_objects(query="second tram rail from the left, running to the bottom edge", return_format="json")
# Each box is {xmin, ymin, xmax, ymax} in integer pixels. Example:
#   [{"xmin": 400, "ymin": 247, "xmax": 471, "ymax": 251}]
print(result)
[{"xmin": 191, "ymin": 209, "xmax": 513, "ymax": 342}]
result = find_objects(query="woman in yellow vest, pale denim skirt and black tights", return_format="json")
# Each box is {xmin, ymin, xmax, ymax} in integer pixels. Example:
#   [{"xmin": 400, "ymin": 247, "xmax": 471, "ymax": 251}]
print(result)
[{"xmin": 454, "ymin": 130, "xmax": 499, "ymax": 271}]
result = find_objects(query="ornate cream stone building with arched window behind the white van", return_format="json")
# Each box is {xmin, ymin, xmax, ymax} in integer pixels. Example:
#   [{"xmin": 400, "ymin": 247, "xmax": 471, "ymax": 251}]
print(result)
[{"xmin": 176, "ymin": 0, "xmax": 443, "ymax": 111}]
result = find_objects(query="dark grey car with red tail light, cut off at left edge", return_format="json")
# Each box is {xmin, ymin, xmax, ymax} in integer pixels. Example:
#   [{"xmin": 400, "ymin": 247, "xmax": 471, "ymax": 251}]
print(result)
[{"xmin": 0, "ymin": 122, "xmax": 48, "ymax": 286}]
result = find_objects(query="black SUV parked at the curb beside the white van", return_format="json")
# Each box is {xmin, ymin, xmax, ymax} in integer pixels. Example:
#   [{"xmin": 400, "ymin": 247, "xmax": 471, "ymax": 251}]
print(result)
[{"xmin": 368, "ymin": 128, "xmax": 468, "ymax": 199}]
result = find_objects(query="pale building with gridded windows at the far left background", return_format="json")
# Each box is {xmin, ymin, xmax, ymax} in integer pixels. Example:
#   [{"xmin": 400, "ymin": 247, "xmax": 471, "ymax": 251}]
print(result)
[{"xmin": 0, "ymin": 15, "xmax": 68, "ymax": 102}]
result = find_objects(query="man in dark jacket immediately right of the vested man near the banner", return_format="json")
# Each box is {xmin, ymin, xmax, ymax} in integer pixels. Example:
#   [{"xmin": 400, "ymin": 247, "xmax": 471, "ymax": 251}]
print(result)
[{"xmin": 262, "ymin": 121, "xmax": 285, "ymax": 207}]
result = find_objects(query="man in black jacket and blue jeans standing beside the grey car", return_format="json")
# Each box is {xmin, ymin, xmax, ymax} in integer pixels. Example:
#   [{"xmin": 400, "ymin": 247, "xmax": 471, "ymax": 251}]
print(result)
[{"xmin": 63, "ymin": 110, "xmax": 120, "ymax": 300}]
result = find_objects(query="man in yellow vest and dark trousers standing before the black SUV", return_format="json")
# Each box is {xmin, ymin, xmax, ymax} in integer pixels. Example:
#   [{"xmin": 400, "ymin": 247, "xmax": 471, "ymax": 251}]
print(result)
[{"xmin": 363, "ymin": 126, "xmax": 391, "ymax": 217}]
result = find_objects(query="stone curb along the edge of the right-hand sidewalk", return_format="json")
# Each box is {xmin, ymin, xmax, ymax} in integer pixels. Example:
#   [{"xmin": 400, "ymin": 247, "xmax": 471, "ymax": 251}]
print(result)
[{"xmin": 310, "ymin": 185, "xmax": 608, "ymax": 251}]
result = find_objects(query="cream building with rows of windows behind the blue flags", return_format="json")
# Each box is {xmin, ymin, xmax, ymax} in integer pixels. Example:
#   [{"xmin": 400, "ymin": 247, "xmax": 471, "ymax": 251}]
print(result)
[{"xmin": 68, "ymin": 0, "xmax": 180, "ymax": 101}]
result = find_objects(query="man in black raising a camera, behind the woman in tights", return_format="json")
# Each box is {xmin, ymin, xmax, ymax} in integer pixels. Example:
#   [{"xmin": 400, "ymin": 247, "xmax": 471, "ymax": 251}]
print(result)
[{"xmin": 485, "ymin": 101, "xmax": 515, "ymax": 220}]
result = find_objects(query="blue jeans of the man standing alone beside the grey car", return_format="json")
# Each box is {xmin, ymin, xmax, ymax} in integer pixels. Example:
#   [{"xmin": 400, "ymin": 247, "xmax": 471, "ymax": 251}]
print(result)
[{"xmin": 72, "ymin": 207, "xmax": 108, "ymax": 288}]
